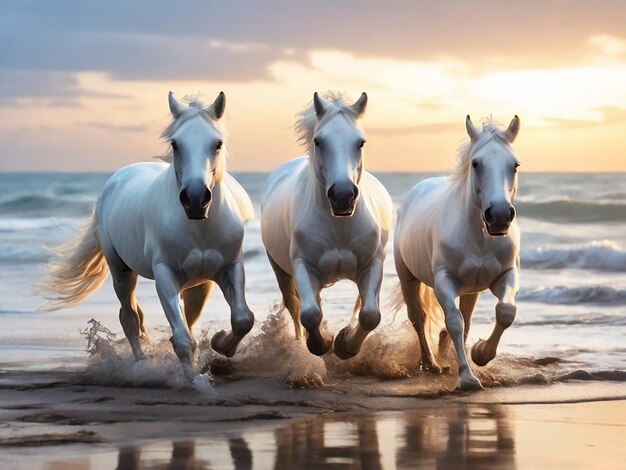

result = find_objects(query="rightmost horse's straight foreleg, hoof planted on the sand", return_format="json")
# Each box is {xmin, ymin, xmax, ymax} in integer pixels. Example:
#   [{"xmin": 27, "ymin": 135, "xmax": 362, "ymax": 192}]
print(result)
[{"xmin": 434, "ymin": 269, "xmax": 483, "ymax": 390}]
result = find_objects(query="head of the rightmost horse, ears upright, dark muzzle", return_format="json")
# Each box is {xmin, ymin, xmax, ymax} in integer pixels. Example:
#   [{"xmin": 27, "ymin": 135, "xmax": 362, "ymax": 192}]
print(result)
[{"xmin": 465, "ymin": 115, "xmax": 520, "ymax": 236}]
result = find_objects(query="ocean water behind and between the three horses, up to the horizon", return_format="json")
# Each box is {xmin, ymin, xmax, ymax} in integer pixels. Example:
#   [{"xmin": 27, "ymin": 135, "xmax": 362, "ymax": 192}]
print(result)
[{"xmin": 0, "ymin": 173, "xmax": 626, "ymax": 378}]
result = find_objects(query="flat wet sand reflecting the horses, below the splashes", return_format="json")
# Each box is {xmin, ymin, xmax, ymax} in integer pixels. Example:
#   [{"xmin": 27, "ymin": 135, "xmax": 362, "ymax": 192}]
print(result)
[{"xmin": 0, "ymin": 371, "xmax": 626, "ymax": 469}]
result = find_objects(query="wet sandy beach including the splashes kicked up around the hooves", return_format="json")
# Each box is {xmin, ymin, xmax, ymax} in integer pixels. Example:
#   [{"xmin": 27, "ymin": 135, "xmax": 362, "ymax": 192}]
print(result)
[{"xmin": 0, "ymin": 314, "xmax": 626, "ymax": 469}]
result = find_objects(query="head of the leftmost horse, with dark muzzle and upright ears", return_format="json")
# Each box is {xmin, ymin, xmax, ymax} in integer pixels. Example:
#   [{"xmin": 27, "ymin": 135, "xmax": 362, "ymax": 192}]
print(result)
[{"xmin": 164, "ymin": 91, "xmax": 226, "ymax": 220}]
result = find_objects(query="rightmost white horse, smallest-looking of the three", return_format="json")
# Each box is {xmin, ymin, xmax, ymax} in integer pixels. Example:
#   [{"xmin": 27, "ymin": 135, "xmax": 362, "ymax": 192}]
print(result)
[{"xmin": 394, "ymin": 116, "xmax": 520, "ymax": 389}]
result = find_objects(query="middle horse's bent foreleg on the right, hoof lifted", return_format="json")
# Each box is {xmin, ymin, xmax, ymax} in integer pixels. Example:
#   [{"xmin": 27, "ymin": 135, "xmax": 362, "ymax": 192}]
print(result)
[{"xmin": 334, "ymin": 254, "xmax": 384, "ymax": 359}]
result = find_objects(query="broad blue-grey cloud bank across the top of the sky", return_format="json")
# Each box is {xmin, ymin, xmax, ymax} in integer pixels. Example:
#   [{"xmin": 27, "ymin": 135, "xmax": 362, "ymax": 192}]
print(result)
[{"xmin": 0, "ymin": 0, "xmax": 626, "ymax": 81}]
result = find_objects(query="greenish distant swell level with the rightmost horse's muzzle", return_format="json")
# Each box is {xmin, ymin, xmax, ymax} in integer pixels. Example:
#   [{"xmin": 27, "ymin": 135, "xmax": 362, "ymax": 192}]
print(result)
[{"xmin": 516, "ymin": 200, "xmax": 626, "ymax": 223}]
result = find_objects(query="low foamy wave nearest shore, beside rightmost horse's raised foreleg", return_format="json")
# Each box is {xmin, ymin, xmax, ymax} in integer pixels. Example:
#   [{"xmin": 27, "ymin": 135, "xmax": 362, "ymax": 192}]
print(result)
[{"xmin": 517, "ymin": 286, "xmax": 626, "ymax": 305}]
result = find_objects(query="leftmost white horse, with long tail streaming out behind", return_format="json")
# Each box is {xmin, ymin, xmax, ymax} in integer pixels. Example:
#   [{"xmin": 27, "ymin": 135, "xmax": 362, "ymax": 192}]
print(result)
[{"xmin": 42, "ymin": 92, "xmax": 254, "ymax": 378}]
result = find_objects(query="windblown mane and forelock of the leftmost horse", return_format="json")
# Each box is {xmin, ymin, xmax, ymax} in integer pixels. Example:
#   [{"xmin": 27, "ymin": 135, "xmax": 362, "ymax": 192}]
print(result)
[{"xmin": 155, "ymin": 93, "xmax": 230, "ymax": 181}]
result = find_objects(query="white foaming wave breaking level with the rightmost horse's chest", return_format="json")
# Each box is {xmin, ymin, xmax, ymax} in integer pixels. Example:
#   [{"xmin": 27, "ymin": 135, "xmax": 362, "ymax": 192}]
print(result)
[{"xmin": 521, "ymin": 240, "xmax": 626, "ymax": 272}]
